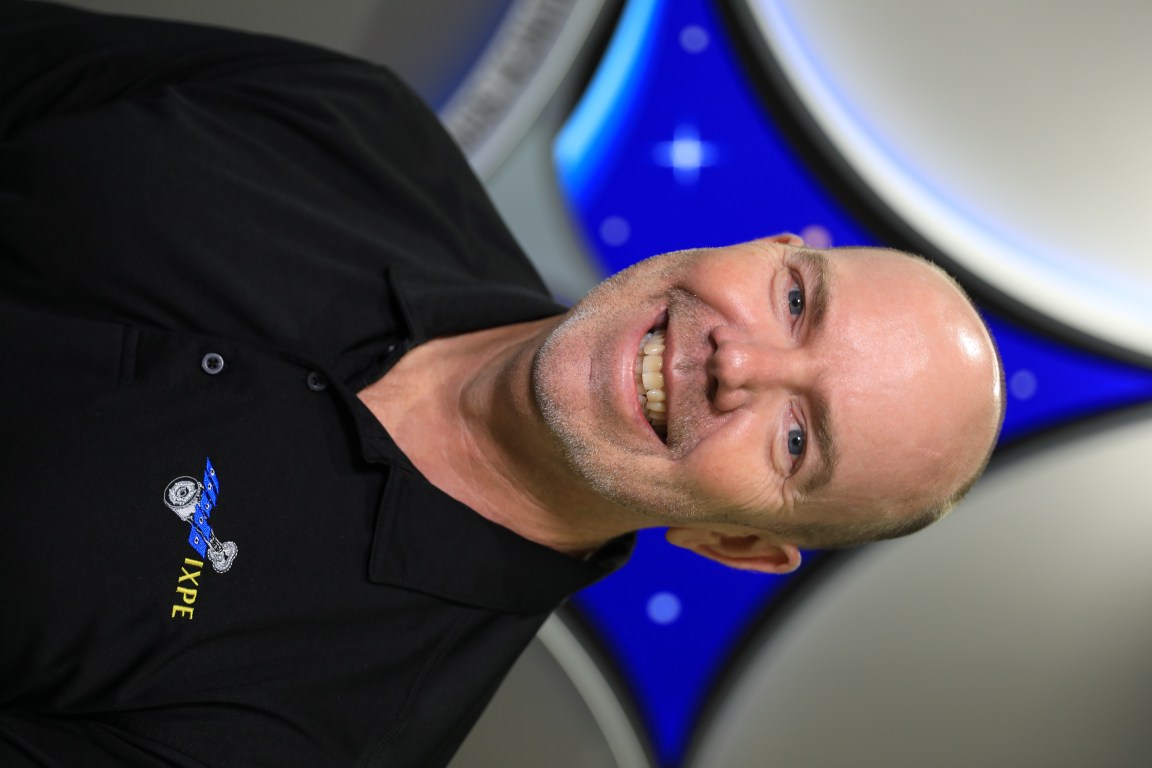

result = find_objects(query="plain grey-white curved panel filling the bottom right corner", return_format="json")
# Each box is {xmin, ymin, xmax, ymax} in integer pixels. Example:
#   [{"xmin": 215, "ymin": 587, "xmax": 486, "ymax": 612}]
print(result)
[{"xmin": 689, "ymin": 412, "xmax": 1152, "ymax": 768}]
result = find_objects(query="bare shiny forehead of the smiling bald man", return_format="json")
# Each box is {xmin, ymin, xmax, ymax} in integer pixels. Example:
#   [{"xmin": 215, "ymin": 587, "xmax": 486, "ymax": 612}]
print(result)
[{"xmin": 794, "ymin": 249, "xmax": 971, "ymax": 516}]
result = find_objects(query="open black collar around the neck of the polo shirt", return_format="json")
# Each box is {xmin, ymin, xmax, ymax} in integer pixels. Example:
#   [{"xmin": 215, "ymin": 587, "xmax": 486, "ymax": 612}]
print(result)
[{"xmin": 340, "ymin": 264, "xmax": 634, "ymax": 613}]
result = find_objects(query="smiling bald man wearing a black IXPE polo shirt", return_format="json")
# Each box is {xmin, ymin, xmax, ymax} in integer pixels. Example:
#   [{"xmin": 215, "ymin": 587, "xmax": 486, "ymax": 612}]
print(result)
[{"xmin": 0, "ymin": 0, "xmax": 1002, "ymax": 768}]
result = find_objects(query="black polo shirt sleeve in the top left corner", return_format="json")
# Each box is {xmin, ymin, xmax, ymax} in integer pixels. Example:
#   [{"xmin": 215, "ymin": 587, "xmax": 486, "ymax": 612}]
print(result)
[{"xmin": 0, "ymin": 0, "xmax": 344, "ymax": 138}]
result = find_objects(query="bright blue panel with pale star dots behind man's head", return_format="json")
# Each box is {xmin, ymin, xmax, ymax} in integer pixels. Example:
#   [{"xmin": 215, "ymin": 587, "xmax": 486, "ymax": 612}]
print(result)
[{"xmin": 554, "ymin": 0, "xmax": 1152, "ymax": 766}]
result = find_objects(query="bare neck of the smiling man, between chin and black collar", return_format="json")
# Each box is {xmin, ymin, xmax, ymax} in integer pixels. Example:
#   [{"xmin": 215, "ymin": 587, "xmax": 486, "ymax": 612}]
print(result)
[{"xmin": 359, "ymin": 318, "xmax": 631, "ymax": 556}]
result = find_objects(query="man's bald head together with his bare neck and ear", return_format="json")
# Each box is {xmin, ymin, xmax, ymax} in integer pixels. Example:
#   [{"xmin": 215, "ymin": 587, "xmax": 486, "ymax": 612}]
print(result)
[{"xmin": 370, "ymin": 235, "xmax": 1003, "ymax": 573}]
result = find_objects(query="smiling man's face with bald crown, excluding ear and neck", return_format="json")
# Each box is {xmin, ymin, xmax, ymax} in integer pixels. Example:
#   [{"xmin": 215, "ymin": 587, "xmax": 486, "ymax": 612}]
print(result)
[{"xmin": 533, "ymin": 237, "xmax": 1000, "ymax": 541}]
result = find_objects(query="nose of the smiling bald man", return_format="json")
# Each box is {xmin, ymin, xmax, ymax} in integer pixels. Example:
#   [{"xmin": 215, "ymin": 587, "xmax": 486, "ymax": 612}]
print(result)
[{"xmin": 707, "ymin": 327, "xmax": 816, "ymax": 411}]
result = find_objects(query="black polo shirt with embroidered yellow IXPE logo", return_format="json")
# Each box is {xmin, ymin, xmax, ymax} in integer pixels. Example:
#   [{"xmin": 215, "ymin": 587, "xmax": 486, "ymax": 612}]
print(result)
[{"xmin": 0, "ymin": 1, "xmax": 629, "ymax": 768}]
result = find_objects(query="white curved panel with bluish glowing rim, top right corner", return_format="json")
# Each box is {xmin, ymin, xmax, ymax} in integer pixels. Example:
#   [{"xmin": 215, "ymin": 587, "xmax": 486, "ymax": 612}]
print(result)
[{"xmin": 746, "ymin": 0, "xmax": 1152, "ymax": 353}]
